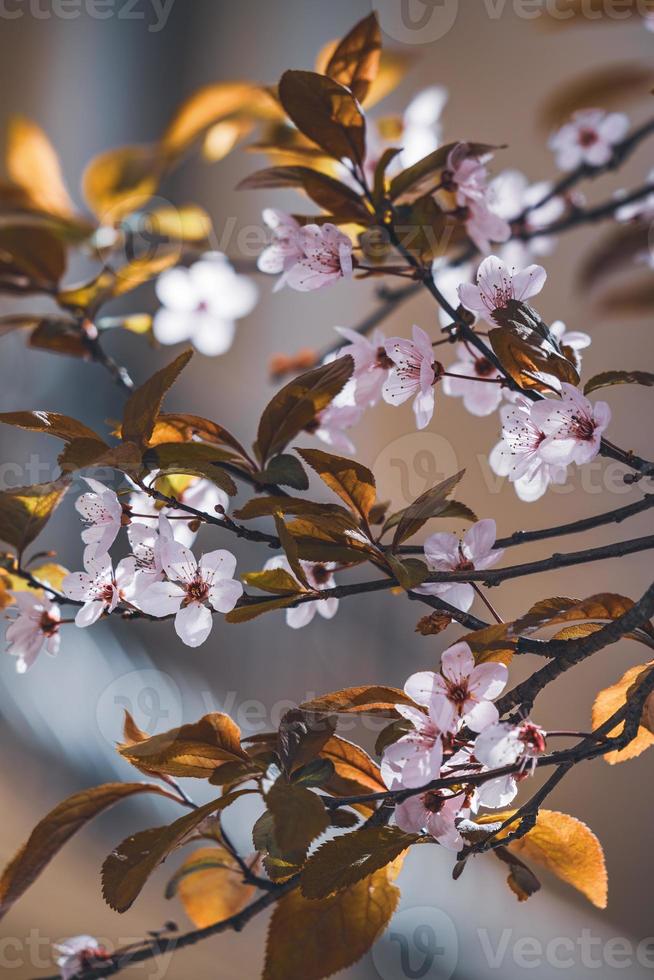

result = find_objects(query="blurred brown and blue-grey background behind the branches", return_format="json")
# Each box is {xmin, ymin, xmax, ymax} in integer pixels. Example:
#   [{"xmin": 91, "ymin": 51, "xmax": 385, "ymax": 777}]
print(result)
[{"xmin": 0, "ymin": 0, "xmax": 654, "ymax": 980}]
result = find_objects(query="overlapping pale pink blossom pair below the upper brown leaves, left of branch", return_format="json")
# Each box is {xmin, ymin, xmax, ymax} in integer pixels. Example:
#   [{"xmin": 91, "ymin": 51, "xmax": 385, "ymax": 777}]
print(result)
[{"xmin": 258, "ymin": 210, "xmax": 352, "ymax": 292}]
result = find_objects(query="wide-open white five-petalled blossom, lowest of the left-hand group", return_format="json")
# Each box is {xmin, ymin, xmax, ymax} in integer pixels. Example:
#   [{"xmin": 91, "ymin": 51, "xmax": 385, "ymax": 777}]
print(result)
[{"xmin": 137, "ymin": 541, "xmax": 243, "ymax": 647}]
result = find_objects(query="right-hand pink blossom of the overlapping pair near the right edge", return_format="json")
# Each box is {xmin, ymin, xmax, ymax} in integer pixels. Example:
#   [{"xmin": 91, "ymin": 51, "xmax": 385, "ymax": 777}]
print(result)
[{"xmin": 531, "ymin": 382, "xmax": 611, "ymax": 466}]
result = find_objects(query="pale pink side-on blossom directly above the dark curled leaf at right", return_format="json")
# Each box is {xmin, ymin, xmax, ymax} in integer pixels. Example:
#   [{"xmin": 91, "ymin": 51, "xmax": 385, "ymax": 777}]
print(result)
[{"xmin": 459, "ymin": 255, "xmax": 547, "ymax": 320}]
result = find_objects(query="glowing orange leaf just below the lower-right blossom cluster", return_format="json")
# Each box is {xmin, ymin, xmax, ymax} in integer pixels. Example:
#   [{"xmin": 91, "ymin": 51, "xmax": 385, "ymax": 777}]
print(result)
[{"xmin": 481, "ymin": 810, "xmax": 607, "ymax": 909}]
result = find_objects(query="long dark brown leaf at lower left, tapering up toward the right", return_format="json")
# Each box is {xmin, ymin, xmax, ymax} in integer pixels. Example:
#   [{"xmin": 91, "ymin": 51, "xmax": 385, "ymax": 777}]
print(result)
[{"xmin": 102, "ymin": 790, "xmax": 248, "ymax": 912}]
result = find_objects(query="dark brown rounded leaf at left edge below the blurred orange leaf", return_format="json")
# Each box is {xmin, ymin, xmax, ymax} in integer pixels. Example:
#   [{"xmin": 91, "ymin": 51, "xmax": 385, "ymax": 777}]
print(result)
[{"xmin": 0, "ymin": 225, "xmax": 66, "ymax": 293}]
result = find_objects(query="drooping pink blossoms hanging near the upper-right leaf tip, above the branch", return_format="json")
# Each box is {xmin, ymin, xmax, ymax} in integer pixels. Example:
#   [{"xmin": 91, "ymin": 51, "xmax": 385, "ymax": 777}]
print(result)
[{"xmin": 442, "ymin": 143, "xmax": 511, "ymax": 252}]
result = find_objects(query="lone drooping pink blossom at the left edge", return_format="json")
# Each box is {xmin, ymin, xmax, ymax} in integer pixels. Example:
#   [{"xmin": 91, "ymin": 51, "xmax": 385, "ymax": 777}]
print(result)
[{"xmin": 5, "ymin": 592, "xmax": 61, "ymax": 674}]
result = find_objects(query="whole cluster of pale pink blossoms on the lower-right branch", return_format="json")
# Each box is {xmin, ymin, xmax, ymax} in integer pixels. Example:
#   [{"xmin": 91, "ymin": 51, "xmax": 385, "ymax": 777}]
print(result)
[{"xmin": 381, "ymin": 642, "xmax": 545, "ymax": 851}]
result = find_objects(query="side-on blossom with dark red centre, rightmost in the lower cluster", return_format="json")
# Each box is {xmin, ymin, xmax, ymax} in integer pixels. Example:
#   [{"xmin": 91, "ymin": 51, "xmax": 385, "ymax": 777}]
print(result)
[{"xmin": 473, "ymin": 721, "xmax": 545, "ymax": 809}]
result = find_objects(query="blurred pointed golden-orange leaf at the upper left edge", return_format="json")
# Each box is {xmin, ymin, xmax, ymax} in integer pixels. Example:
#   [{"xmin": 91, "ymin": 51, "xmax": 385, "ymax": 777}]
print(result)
[{"xmin": 6, "ymin": 116, "xmax": 75, "ymax": 218}]
